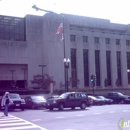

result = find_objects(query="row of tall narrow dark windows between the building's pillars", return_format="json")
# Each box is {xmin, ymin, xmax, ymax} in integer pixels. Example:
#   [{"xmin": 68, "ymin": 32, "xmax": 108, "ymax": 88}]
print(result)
[{"xmin": 71, "ymin": 49, "xmax": 130, "ymax": 87}]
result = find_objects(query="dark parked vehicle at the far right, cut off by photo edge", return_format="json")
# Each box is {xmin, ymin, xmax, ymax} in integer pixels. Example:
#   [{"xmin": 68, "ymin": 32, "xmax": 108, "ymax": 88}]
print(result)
[{"xmin": 106, "ymin": 92, "xmax": 130, "ymax": 104}]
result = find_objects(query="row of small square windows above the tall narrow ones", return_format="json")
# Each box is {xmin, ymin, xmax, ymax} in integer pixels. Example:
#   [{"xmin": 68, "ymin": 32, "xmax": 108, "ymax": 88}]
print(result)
[{"xmin": 70, "ymin": 35, "xmax": 130, "ymax": 46}]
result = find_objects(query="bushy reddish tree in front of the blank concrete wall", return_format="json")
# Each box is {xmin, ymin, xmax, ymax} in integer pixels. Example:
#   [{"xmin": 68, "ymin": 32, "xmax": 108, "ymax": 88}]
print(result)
[{"xmin": 31, "ymin": 74, "xmax": 55, "ymax": 89}]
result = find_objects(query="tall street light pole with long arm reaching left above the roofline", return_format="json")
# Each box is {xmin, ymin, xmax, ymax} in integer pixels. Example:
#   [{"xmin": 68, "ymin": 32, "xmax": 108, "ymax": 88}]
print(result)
[{"xmin": 32, "ymin": 5, "xmax": 68, "ymax": 91}]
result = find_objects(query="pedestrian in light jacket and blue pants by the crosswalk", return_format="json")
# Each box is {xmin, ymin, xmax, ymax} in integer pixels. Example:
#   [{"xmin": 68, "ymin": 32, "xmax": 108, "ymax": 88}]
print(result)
[{"xmin": 1, "ymin": 92, "xmax": 13, "ymax": 116}]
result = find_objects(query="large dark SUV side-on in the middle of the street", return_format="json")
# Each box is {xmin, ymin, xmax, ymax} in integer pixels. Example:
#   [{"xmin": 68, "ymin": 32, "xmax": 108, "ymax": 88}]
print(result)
[{"xmin": 47, "ymin": 92, "xmax": 90, "ymax": 110}]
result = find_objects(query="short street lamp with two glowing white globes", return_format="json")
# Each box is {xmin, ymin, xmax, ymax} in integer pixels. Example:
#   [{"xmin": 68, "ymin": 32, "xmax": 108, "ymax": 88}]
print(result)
[{"xmin": 64, "ymin": 58, "xmax": 70, "ymax": 92}]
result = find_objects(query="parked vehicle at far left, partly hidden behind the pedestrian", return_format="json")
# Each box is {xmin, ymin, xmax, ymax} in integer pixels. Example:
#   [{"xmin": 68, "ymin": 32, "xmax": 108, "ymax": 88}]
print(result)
[{"xmin": 1, "ymin": 93, "xmax": 25, "ymax": 111}]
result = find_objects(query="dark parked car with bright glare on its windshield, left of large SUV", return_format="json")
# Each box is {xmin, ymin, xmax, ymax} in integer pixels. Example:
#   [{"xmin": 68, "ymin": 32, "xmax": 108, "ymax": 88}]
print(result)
[{"xmin": 25, "ymin": 96, "xmax": 46, "ymax": 109}]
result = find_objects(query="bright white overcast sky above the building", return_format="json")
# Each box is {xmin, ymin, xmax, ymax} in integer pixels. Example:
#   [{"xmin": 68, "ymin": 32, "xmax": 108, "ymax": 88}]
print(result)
[{"xmin": 0, "ymin": 0, "xmax": 130, "ymax": 24}]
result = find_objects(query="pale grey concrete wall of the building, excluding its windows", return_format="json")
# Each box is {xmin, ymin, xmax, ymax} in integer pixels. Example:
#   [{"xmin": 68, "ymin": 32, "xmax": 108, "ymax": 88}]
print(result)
[{"xmin": 0, "ymin": 14, "xmax": 130, "ymax": 88}]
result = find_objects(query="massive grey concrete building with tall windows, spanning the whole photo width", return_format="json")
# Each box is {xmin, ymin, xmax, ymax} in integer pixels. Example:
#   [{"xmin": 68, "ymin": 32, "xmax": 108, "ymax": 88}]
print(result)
[{"xmin": 0, "ymin": 13, "xmax": 130, "ymax": 89}]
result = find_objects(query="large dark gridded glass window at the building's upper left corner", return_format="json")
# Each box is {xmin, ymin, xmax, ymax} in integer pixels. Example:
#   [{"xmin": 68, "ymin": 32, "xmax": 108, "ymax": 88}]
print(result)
[{"xmin": 0, "ymin": 15, "xmax": 26, "ymax": 41}]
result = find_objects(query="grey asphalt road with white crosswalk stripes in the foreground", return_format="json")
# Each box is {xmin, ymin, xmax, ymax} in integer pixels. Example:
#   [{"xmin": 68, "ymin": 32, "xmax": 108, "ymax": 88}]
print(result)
[{"xmin": 0, "ymin": 104, "xmax": 130, "ymax": 130}]
